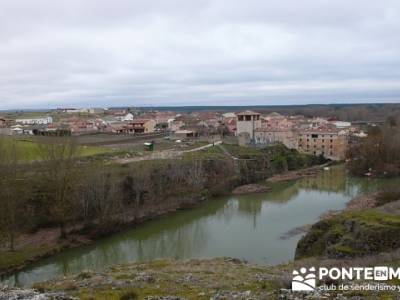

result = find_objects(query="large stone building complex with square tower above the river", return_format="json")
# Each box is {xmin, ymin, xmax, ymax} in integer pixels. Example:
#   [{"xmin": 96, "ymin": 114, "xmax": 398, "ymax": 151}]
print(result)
[{"xmin": 237, "ymin": 111, "xmax": 351, "ymax": 160}]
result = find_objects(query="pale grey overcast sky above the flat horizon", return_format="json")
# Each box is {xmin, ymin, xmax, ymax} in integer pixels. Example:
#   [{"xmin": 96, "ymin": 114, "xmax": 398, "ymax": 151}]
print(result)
[{"xmin": 0, "ymin": 0, "xmax": 400, "ymax": 109}]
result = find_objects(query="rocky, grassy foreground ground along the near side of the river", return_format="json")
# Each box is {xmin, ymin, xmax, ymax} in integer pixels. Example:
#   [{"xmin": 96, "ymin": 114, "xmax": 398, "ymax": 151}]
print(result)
[{"xmin": 0, "ymin": 255, "xmax": 399, "ymax": 300}]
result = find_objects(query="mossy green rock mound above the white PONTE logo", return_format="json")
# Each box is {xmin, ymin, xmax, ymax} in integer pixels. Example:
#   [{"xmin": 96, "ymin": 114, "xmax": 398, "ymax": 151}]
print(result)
[{"xmin": 296, "ymin": 204, "xmax": 400, "ymax": 259}]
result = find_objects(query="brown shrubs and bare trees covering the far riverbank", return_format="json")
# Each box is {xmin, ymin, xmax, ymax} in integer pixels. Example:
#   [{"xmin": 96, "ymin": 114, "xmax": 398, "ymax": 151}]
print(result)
[{"xmin": 0, "ymin": 137, "xmax": 322, "ymax": 272}]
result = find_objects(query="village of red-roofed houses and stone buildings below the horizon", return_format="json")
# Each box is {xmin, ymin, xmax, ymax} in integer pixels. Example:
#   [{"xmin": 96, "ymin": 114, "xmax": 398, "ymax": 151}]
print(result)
[{"xmin": 0, "ymin": 108, "xmax": 367, "ymax": 161}]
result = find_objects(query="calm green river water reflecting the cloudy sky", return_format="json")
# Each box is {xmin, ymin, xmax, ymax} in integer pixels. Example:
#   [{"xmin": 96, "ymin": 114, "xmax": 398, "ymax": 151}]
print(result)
[{"xmin": 3, "ymin": 166, "xmax": 400, "ymax": 286}]
